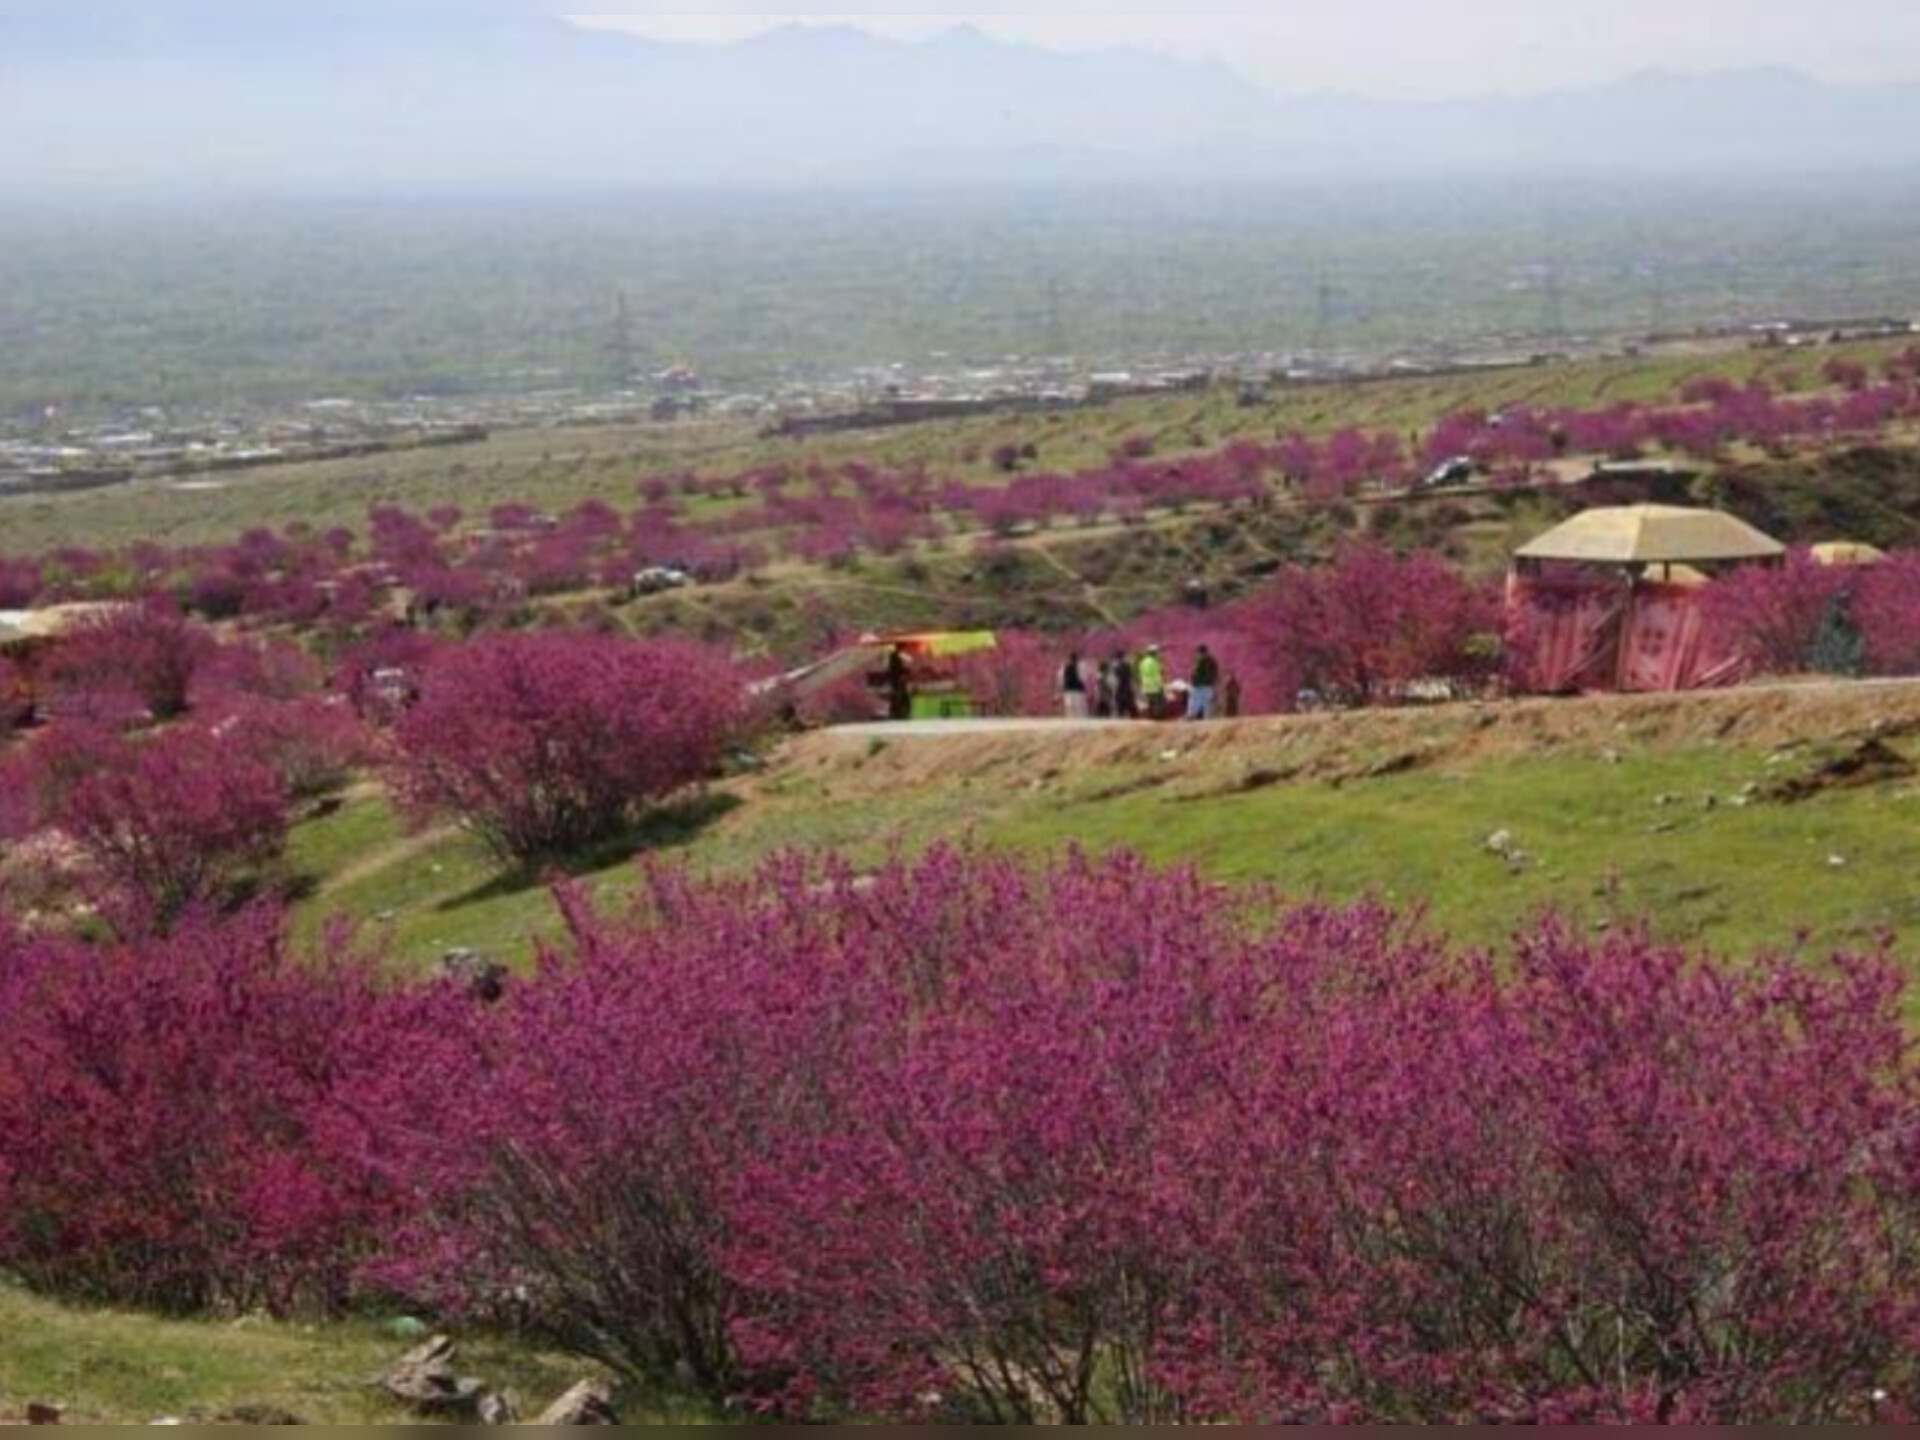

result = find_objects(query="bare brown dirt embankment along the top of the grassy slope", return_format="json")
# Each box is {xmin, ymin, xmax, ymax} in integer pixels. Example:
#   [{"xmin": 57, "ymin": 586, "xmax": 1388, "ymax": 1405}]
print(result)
[{"xmin": 766, "ymin": 682, "xmax": 1920, "ymax": 799}]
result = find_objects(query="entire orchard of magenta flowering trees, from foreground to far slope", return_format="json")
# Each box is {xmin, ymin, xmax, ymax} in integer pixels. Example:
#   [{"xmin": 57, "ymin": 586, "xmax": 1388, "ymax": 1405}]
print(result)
[{"xmin": 11, "ymin": 353, "xmax": 1920, "ymax": 1425}]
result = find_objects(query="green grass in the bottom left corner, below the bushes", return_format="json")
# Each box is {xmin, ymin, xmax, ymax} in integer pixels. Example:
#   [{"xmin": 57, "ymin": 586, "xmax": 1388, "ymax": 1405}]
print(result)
[{"xmin": 0, "ymin": 1284, "xmax": 721, "ymax": 1425}]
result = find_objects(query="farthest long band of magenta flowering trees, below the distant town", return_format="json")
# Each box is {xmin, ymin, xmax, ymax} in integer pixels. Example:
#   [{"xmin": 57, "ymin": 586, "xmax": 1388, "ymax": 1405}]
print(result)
[{"xmin": 0, "ymin": 353, "xmax": 1920, "ymax": 637}]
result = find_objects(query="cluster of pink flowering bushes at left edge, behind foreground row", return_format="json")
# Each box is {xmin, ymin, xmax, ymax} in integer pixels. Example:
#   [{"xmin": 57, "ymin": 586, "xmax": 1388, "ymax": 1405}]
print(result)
[{"xmin": 0, "ymin": 607, "xmax": 372, "ymax": 933}]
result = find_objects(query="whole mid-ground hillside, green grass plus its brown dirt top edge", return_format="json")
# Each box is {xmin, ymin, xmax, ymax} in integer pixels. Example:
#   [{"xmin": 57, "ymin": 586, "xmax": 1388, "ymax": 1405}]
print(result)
[{"xmin": 292, "ymin": 685, "xmax": 1920, "ymax": 990}]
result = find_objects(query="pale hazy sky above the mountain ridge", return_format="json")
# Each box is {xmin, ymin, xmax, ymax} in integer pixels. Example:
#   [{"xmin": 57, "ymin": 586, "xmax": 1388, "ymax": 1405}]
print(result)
[{"xmin": 576, "ymin": 0, "xmax": 1920, "ymax": 96}]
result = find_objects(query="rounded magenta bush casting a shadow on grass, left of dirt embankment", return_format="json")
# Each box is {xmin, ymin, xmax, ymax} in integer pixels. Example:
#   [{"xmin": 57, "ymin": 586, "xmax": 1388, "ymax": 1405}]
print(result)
[{"xmin": 392, "ymin": 634, "xmax": 747, "ymax": 862}]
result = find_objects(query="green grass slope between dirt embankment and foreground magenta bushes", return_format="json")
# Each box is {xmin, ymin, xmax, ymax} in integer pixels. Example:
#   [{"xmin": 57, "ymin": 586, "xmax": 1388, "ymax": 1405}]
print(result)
[{"xmin": 280, "ymin": 733, "xmax": 1920, "ymax": 972}]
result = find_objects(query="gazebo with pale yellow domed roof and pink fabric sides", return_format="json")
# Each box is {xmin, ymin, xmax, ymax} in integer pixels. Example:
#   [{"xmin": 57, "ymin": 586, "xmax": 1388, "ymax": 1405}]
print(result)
[{"xmin": 1507, "ymin": 505, "xmax": 1786, "ymax": 695}]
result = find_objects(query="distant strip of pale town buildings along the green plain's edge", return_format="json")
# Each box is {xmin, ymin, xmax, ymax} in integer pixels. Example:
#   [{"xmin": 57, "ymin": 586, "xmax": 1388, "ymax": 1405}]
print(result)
[{"xmin": 0, "ymin": 317, "xmax": 1920, "ymax": 497}]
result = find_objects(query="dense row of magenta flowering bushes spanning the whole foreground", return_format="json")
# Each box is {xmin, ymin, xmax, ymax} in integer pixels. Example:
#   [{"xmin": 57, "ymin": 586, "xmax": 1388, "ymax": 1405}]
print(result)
[{"xmin": 0, "ymin": 851, "xmax": 1920, "ymax": 1423}]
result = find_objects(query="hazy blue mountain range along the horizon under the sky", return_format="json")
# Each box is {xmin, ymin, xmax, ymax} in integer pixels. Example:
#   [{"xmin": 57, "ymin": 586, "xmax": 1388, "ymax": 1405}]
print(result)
[{"xmin": 0, "ymin": 0, "xmax": 1920, "ymax": 192}]
